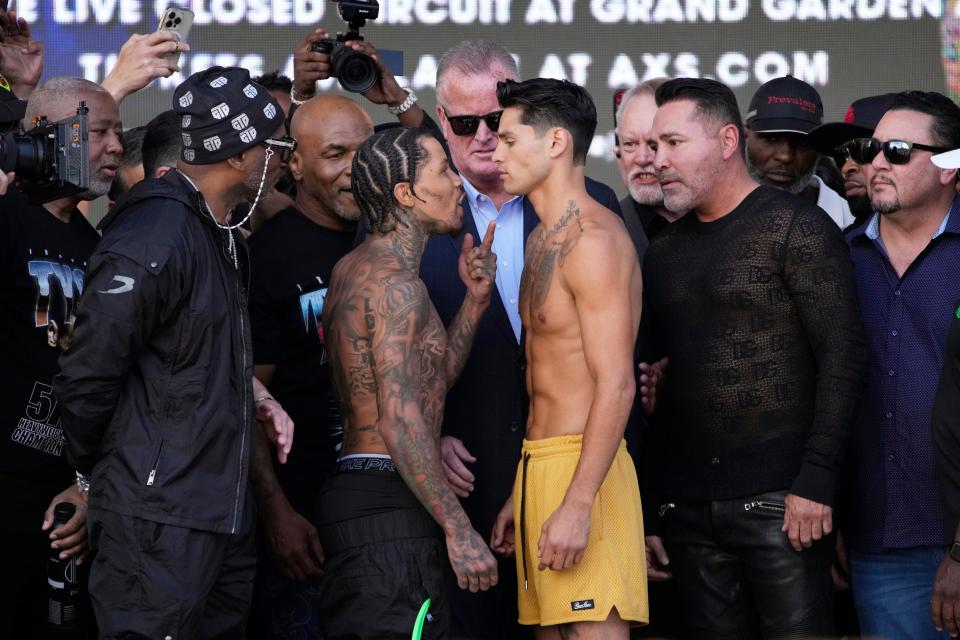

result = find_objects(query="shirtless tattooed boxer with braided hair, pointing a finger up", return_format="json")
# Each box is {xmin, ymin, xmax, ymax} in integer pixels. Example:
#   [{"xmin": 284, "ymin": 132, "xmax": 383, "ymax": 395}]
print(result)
[{"xmin": 319, "ymin": 129, "xmax": 497, "ymax": 640}]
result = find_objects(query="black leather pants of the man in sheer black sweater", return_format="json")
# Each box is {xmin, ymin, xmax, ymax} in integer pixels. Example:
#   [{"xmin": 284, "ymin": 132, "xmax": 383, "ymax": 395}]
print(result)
[{"xmin": 661, "ymin": 491, "xmax": 834, "ymax": 640}]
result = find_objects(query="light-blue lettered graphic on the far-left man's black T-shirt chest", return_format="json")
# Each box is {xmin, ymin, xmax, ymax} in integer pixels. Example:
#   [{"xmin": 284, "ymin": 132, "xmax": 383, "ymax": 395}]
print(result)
[{"xmin": 27, "ymin": 258, "xmax": 83, "ymax": 351}]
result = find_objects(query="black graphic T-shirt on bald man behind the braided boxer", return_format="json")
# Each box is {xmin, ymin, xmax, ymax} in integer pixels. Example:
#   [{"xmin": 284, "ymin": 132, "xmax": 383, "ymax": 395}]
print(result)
[{"xmin": 250, "ymin": 207, "xmax": 356, "ymax": 516}]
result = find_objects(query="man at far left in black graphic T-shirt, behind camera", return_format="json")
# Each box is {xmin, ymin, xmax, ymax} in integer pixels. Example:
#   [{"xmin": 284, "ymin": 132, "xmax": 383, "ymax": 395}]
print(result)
[{"xmin": 0, "ymin": 78, "xmax": 122, "ymax": 637}]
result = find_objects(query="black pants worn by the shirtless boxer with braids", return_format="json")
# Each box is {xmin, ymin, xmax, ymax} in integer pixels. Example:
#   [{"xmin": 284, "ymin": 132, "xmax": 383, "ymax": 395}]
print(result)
[{"xmin": 318, "ymin": 464, "xmax": 450, "ymax": 640}]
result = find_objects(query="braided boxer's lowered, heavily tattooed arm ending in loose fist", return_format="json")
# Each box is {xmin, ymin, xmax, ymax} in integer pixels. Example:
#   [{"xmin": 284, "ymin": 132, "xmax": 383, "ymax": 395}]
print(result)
[{"xmin": 366, "ymin": 280, "xmax": 497, "ymax": 592}]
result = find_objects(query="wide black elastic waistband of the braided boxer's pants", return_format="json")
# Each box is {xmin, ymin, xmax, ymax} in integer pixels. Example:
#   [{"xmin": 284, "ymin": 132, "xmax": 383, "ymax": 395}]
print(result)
[{"xmin": 317, "ymin": 508, "xmax": 440, "ymax": 553}]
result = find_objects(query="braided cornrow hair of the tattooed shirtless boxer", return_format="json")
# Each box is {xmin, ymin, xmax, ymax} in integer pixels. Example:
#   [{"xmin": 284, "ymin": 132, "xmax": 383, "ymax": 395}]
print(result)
[{"xmin": 351, "ymin": 127, "xmax": 430, "ymax": 233}]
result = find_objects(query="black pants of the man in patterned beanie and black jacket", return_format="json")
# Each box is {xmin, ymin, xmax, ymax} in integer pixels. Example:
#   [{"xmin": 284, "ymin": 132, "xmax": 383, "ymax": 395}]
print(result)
[{"xmin": 90, "ymin": 491, "xmax": 256, "ymax": 640}]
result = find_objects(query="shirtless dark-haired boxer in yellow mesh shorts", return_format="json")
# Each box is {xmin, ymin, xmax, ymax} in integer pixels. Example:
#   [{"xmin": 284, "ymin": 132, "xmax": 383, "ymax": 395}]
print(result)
[{"xmin": 490, "ymin": 78, "xmax": 648, "ymax": 640}]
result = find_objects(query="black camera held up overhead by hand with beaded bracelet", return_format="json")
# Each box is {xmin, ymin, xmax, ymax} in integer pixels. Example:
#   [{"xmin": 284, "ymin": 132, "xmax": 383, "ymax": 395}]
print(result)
[{"xmin": 310, "ymin": 0, "xmax": 380, "ymax": 93}]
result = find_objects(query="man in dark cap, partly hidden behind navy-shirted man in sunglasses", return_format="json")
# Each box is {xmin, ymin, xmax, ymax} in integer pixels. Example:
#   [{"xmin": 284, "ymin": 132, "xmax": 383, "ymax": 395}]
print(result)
[{"xmin": 810, "ymin": 93, "xmax": 895, "ymax": 225}]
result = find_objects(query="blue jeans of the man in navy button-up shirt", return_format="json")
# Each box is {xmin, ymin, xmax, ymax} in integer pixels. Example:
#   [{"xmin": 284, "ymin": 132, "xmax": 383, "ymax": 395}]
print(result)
[{"xmin": 850, "ymin": 547, "xmax": 950, "ymax": 640}]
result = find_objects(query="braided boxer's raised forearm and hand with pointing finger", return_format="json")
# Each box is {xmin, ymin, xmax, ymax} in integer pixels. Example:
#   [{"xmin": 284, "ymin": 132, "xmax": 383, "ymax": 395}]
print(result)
[{"xmin": 443, "ymin": 220, "xmax": 497, "ymax": 390}]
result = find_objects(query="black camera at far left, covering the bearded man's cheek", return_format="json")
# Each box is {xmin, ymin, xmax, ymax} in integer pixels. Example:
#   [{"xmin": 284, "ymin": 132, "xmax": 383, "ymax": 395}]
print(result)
[{"xmin": 0, "ymin": 102, "xmax": 90, "ymax": 204}]
